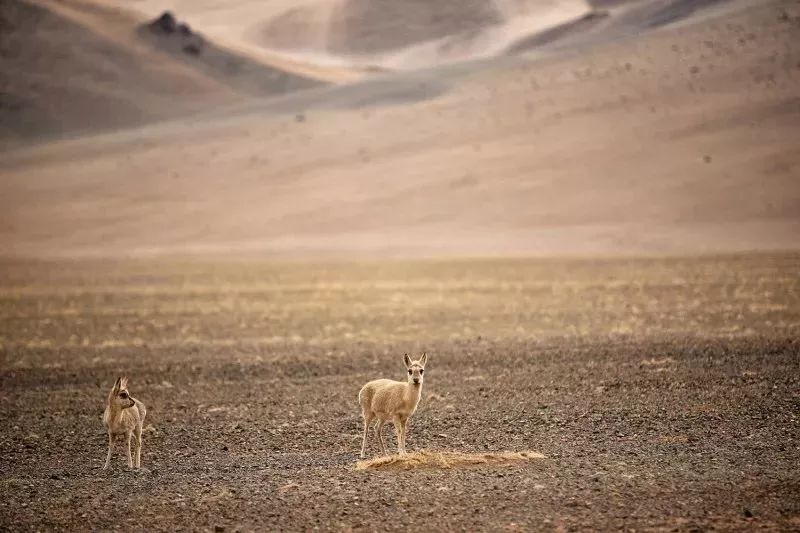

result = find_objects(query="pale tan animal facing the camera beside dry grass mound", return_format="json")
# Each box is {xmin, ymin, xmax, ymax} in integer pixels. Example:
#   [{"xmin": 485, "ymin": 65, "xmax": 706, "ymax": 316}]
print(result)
[{"xmin": 358, "ymin": 353, "xmax": 428, "ymax": 459}]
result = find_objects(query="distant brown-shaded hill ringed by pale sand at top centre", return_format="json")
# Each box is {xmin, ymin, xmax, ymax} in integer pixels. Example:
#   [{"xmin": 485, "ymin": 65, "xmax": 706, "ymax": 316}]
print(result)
[{"xmin": 260, "ymin": 0, "xmax": 590, "ymax": 70}]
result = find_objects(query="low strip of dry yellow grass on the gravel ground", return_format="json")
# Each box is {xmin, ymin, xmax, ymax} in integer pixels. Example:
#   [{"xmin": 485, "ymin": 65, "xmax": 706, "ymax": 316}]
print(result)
[{"xmin": 356, "ymin": 450, "xmax": 545, "ymax": 470}]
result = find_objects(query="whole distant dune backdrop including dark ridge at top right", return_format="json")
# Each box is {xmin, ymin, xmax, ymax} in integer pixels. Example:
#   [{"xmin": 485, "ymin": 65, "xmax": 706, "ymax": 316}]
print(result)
[{"xmin": 123, "ymin": 0, "xmax": 743, "ymax": 71}]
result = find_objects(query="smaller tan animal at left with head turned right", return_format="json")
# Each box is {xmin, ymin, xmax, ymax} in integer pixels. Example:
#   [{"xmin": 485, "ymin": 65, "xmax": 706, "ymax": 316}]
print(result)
[{"xmin": 103, "ymin": 378, "xmax": 147, "ymax": 470}]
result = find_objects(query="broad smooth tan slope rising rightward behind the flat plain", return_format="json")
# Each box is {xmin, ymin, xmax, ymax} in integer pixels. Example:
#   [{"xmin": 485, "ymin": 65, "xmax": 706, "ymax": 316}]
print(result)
[{"xmin": 0, "ymin": 1, "xmax": 800, "ymax": 256}]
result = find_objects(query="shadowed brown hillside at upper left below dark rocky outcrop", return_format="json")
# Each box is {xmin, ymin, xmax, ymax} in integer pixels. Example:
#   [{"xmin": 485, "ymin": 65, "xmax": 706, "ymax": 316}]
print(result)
[{"xmin": 0, "ymin": 0, "xmax": 319, "ymax": 145}]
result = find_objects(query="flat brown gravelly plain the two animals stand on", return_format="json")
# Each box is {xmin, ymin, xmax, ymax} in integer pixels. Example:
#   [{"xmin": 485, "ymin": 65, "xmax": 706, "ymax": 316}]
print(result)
[{"xmin": 0, "ymin": 254, "xmax": 800, "ymax": 531}]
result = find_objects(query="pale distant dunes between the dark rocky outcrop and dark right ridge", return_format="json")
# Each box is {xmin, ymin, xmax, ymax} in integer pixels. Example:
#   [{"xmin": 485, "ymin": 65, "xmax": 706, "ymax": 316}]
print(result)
[{"xmin": 130, "ymin": 0, "xmax": 591, "ymax": 70}]
